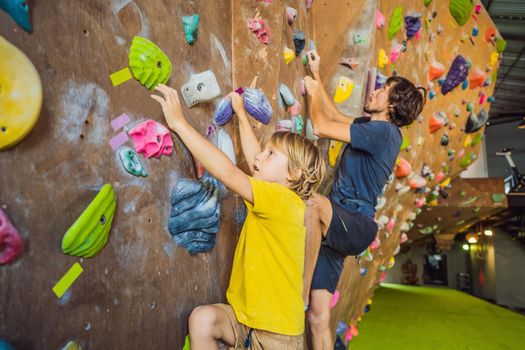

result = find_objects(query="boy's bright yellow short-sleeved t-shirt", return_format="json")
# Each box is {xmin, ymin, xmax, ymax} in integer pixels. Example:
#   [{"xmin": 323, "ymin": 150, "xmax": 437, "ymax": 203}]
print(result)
[{"xmin": 226, "ymin": 177, "xmax": 306, "ymax": 335}]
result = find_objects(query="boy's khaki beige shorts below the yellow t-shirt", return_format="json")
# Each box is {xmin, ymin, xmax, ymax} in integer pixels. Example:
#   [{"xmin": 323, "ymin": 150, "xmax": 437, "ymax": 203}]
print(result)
[{"xmin": 214, "ymin": 304, "xmax": 304, "ymax": 350}]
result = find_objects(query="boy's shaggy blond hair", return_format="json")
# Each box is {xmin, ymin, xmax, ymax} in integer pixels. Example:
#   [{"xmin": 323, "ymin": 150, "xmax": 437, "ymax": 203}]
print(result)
[{"xmin": 268, "ymin": 131, "xmax": 325, "ymax": 199}]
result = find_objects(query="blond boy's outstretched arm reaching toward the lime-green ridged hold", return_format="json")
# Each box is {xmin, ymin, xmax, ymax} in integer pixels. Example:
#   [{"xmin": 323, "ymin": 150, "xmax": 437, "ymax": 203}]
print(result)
[{"xmin": 151, "ymin": 84, "xmax": 253, "ymax": 203}]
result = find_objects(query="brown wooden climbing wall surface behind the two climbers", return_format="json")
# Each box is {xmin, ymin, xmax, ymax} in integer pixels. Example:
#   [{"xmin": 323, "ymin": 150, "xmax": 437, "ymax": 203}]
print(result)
[{"xmin": 0, "ymin": 0, "xmax": 497, "ymax": 349}]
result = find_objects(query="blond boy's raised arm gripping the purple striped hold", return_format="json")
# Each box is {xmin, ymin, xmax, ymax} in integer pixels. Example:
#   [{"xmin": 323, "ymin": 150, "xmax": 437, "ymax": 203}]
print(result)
[{"xmin": 226, "ymin": 92, "xmax": 261, "ymax": 174}]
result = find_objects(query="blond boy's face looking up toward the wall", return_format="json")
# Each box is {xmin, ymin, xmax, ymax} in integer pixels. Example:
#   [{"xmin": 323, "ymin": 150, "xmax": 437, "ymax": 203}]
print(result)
[{"xmin": 253, "ymin": 142, "xmax": 289, "ymax": 186}]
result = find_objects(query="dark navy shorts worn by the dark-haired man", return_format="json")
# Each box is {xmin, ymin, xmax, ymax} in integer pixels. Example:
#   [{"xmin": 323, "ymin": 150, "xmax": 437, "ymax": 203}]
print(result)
[{"xmin": 311, "ymin": 200, "xmax": 377, "ymax": 294}]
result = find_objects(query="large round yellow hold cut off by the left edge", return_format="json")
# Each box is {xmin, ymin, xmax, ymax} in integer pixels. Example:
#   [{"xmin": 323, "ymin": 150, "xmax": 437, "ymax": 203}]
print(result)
[{"xmin": 0, "ymin": 36, "xmax": 42, "ymax": 150}]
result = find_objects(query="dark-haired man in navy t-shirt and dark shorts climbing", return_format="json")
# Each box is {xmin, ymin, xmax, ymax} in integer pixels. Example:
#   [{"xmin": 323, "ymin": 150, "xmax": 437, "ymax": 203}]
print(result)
[{"xmin": 305, "ymin": 51, "xmax": 426, "ymax": 349}]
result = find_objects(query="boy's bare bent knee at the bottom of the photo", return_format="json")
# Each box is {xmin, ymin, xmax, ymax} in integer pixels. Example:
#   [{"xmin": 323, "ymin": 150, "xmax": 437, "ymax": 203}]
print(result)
[{"xmin": 188, "ymin": 305, "xmax": 235, "ymax": 350}]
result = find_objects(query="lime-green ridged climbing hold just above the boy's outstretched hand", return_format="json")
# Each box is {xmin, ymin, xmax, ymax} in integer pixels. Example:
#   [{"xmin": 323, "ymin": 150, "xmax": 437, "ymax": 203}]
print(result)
[{"xmin": 129, "ymin": 36, "xmax": 171, "ymax": 90}]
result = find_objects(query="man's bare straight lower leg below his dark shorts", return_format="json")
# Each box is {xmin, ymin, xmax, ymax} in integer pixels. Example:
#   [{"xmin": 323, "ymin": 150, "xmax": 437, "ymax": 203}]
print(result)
[{"xmin": 307, "ymin": 289, "xmax": 334, "ymax": 350}]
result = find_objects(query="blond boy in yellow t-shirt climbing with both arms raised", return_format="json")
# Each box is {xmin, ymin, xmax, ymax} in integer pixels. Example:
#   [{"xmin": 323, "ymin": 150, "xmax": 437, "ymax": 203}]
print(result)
[{"xmin": 152, "ymin": 85, "xmax": 324, "ymax": 350}]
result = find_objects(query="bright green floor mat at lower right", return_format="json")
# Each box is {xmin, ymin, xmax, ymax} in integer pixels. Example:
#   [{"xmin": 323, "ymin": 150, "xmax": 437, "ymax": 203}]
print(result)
[{"xmin": 349, "ymin": 283, "xmax": 525, "ymax": 350}]
